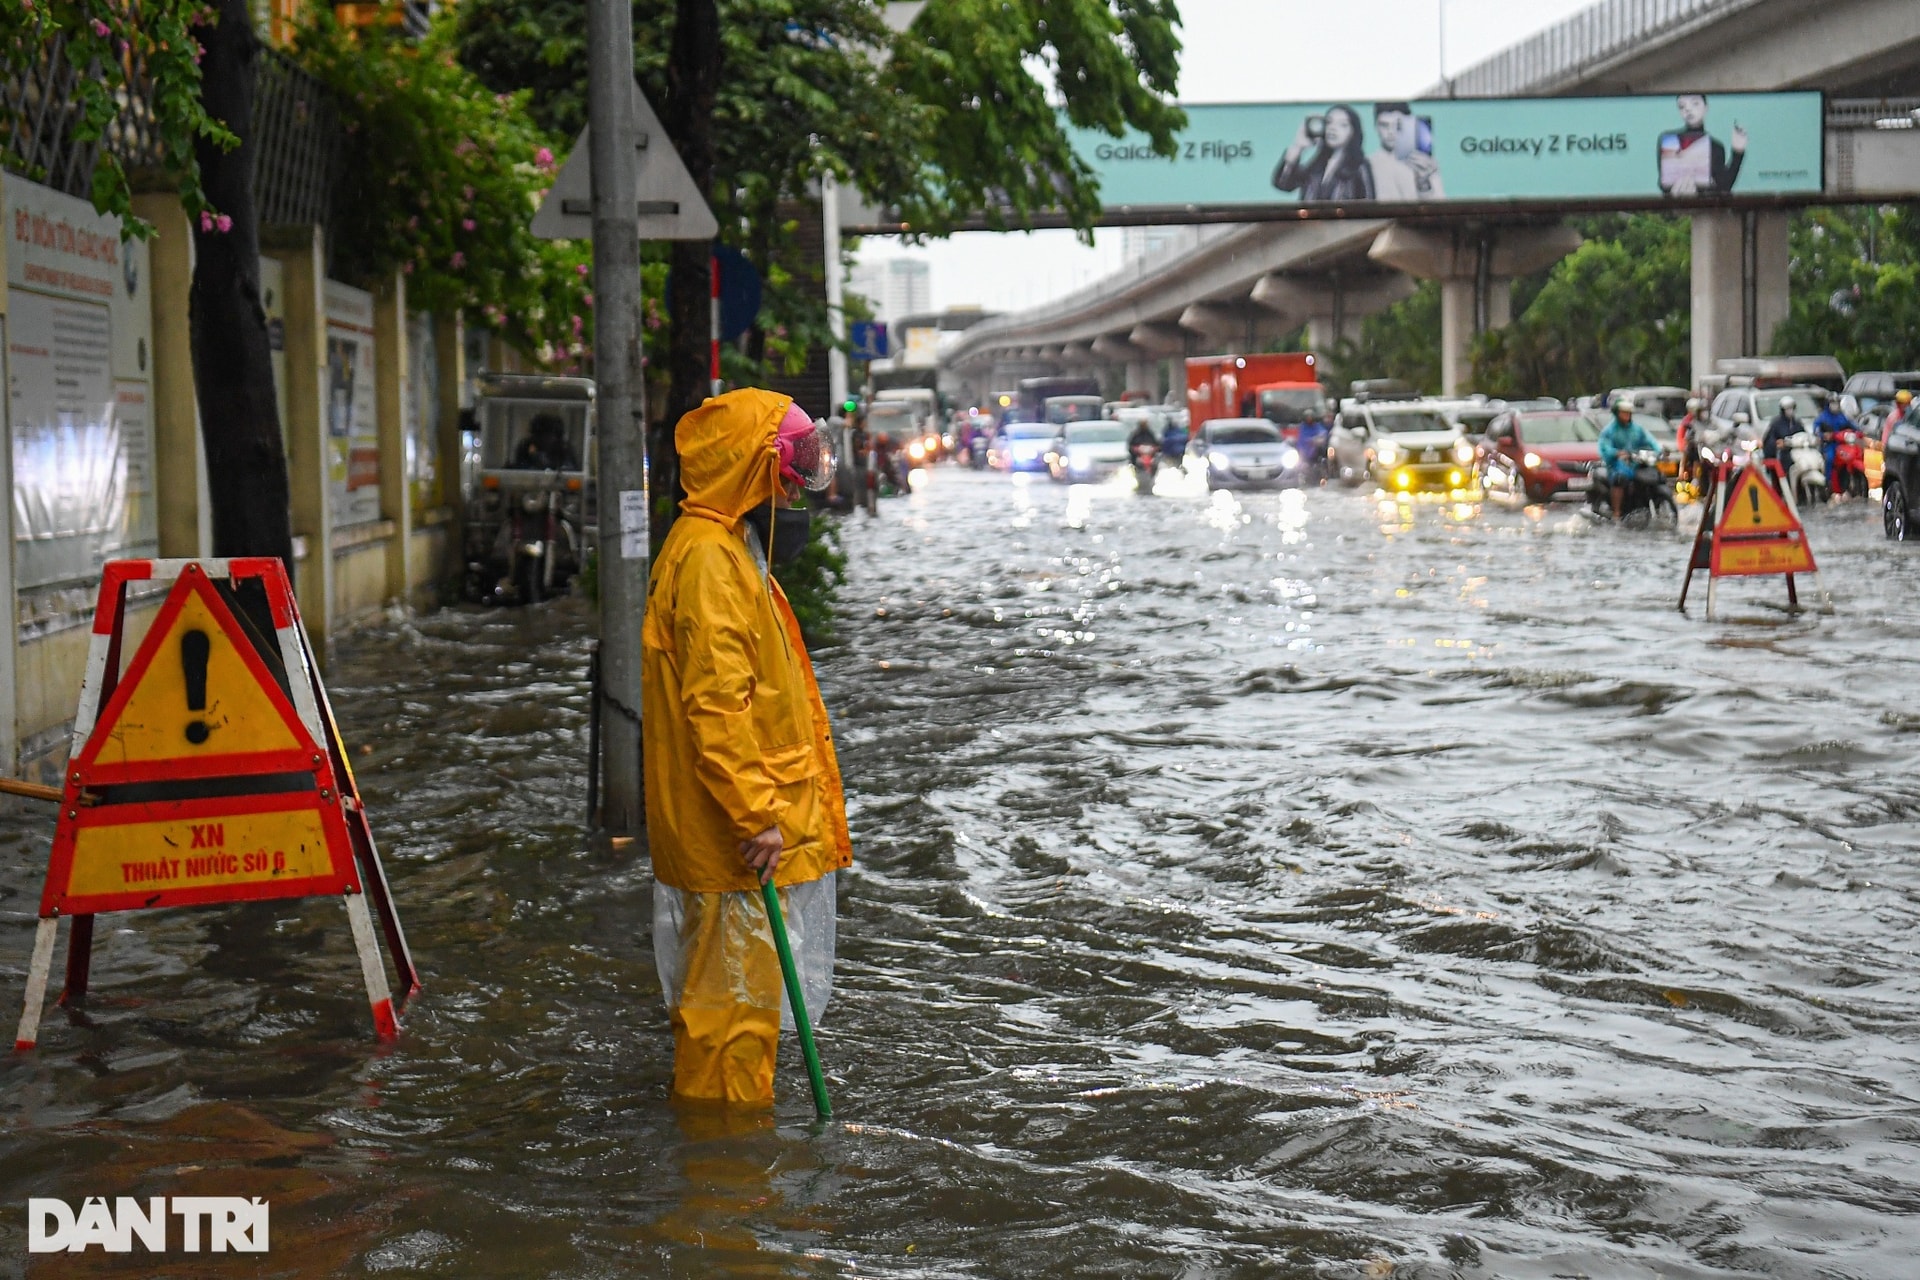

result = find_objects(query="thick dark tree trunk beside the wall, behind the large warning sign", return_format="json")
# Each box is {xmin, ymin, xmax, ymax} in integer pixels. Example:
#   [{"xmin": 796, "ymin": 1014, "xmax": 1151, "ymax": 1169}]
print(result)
[{"xmin": 188, "ymin": 0, "xmax": 289, "ymax": 578}]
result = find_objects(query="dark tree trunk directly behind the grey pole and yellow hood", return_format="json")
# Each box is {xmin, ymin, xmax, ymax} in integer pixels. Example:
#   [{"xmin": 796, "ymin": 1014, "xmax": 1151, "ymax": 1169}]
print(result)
[{"xmin": 647, "ymin": 0, "xmax": 722, "ymax": 549}]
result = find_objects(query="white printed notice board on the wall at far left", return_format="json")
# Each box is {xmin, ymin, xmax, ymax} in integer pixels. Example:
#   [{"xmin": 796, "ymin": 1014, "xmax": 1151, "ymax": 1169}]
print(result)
[{"xmin": 4, "ymin": 175, "xmax": 159, "ymax": 589}]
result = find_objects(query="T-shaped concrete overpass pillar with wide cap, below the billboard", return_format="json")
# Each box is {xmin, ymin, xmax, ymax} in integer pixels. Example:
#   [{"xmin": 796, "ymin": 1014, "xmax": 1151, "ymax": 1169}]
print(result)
[{"xmin": 1367, "ymin": 225, "xmax": 1580, "ymax": 395}]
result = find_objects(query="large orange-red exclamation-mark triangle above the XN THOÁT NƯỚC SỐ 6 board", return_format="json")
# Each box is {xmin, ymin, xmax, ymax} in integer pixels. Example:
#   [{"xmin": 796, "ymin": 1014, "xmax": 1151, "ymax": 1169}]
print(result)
[{"xmin": 73, "ymin": 572, "xmax": 321, "ymax": 787}]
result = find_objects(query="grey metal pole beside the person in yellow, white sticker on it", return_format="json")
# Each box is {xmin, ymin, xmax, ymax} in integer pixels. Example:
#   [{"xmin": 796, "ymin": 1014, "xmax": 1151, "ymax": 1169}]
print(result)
[{"xmin": 588, "ymin": 0, "xmax": 647, "ymax": 835}]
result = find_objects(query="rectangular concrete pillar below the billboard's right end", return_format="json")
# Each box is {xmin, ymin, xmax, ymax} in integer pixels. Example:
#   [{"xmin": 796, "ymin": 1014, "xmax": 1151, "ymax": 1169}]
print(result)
[{"xmin": 1693, "ymin": 209, "xmax": 1788, "ymax": 386}]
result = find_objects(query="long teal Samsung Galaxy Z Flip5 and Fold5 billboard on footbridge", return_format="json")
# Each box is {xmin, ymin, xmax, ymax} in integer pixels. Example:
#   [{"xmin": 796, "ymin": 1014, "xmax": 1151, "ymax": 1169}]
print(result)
[{"xmin": 1069, "ymin": 92, "xmax": 1824, "ymax": 211}]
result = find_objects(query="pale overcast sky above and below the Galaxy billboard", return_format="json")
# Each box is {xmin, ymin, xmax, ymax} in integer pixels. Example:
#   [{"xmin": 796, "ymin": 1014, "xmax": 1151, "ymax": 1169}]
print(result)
[{"xmin": 860, "ymin": 0, "xmax": 1592, "ymax": 311}]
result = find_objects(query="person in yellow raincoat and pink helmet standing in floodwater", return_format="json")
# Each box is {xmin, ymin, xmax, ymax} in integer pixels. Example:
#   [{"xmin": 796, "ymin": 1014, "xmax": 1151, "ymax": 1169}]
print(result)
[{"xmin": 641, "ymin": 390, "xmax": 852, "ymax": 1103}]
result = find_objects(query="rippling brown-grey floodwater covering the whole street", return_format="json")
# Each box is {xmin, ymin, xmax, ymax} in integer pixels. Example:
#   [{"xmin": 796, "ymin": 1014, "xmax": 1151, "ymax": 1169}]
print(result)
[{"xmin": 0, "ymin": 468, "xmax": 1920, "ymax": 1280}]
